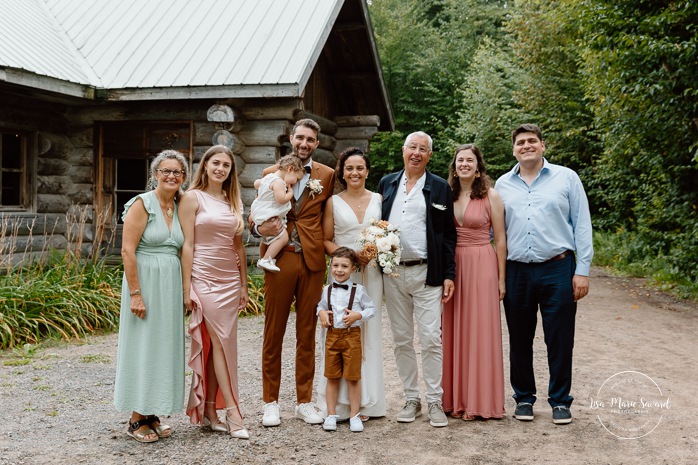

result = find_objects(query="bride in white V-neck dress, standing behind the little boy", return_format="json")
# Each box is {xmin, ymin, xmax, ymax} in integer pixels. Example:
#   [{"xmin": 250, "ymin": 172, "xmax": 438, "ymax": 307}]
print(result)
[{"xmin": 317, "ymin": 147, "xmax": 386, "ymax": 420}]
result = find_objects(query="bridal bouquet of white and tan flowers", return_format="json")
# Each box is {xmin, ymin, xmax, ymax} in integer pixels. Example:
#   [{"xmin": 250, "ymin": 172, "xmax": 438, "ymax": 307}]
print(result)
[{"xmin": 357, "ymin": 219, "xmax": 402, "ymax": 278}]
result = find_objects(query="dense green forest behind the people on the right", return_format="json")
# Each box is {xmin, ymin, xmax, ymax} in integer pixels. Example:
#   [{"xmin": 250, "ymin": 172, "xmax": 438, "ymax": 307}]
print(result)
[{"xmin": 369, "ymin": 0, "xmax": 698, "ymax": 290}]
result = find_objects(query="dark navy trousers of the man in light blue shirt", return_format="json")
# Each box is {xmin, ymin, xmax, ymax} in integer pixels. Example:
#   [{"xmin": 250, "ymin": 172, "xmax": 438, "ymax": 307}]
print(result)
[{"xmin": 504, "ymin": 254, "xmax": 577, "ymax": 407}]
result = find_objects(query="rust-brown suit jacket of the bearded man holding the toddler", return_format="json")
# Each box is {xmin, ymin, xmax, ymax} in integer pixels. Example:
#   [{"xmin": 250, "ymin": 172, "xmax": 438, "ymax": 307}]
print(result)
[{"xmin": 262, "ymin": 160, "xmax": 335, "ymax": 271}]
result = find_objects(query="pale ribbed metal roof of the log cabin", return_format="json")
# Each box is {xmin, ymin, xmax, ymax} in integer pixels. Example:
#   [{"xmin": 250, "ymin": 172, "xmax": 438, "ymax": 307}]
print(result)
[{"xmin": 0, "ymin": 0, "xmax": 343, "ymax": 97}]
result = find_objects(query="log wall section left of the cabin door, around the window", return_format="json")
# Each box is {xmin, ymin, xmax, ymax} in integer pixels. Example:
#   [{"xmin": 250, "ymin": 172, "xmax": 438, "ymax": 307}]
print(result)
[{"xmin": 0, "ymin": 92, "xmax": 93, "ymax": 265}]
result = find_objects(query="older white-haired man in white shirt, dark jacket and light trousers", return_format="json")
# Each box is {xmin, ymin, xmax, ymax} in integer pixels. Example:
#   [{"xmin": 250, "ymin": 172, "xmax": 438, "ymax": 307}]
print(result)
[{"xmin": 378, "ymin": 132, "xmax": 456, "ymax": 427}]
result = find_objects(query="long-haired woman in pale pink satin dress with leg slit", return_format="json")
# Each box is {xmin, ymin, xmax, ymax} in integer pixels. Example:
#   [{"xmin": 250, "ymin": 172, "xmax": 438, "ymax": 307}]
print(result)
[{"xmin": 179, "ymin": 145, "xmax": 250, "ymax": 439}]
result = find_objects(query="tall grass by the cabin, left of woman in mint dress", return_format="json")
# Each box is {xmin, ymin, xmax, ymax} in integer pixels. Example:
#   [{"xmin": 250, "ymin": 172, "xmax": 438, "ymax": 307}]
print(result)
[{"xmin": 0, "ymin": 207, "xmax": 121, "ymax": 349}]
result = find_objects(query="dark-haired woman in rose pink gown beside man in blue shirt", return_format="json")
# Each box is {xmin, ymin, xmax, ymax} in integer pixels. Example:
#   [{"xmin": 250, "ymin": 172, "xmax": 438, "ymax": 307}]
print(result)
[{"xmin": 442, "ymin": 144, "xmax": 507, "ymax": 420}]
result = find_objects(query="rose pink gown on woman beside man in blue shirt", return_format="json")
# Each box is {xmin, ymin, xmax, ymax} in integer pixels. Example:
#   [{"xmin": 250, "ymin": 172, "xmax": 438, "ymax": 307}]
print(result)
[{"xmin": 441, "ymin": 197, "xmax": 505, "ymax": 418}]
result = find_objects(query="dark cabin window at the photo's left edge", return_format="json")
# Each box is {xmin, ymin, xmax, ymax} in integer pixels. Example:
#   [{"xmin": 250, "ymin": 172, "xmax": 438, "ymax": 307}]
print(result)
[{"xmin": 0, "ymin": 132, "xmax": 27, "ymax": 210}]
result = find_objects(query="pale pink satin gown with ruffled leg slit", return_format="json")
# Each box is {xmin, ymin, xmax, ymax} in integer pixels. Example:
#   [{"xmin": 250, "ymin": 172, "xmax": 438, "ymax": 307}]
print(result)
[{"xmin": 187, "ymin": 190, "xmax": 242, "ymax": 424}]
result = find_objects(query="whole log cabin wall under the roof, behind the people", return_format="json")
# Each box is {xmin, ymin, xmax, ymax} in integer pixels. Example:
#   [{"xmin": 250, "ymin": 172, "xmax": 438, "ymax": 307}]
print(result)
[{"xmin": 0, "ymin": 92, "xmax": 379, "ymax": 262}]
